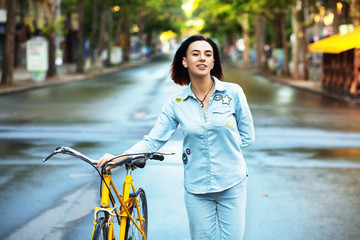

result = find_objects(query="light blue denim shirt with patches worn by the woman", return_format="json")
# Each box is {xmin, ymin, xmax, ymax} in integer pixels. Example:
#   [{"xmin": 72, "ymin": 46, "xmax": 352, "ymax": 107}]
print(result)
[{"xmin": 126, "ymin": 77, "xmax": 255, "ymax": 194}]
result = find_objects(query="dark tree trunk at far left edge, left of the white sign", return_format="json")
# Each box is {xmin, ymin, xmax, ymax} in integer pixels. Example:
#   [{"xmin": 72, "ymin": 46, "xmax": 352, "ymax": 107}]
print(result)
[{"xmin": 1, "ymin": 0, "xmax": 16, "ymax": 85}]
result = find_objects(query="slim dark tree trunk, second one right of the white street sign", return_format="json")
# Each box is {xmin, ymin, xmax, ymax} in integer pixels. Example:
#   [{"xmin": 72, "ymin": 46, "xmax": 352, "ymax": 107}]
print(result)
[{"xmin": 76, "ymin": 0, "xmax": 84, "ymax": 73}]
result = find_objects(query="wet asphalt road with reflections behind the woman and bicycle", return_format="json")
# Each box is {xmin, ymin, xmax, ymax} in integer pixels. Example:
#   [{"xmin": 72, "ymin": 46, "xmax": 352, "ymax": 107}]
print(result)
[{"xmin": 0, "ymin": 55, "xmax": 360, "ymax": 240}]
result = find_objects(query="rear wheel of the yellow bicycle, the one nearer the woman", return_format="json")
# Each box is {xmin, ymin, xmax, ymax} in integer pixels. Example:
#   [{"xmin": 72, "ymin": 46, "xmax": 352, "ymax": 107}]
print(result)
[{"xmin": 125, "ymin": 188, "xmax": 148, "ymax": 240}]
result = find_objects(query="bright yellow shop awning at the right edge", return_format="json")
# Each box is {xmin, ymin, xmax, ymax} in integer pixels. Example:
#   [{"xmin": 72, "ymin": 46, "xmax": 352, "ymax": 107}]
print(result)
[{"xmin": 309, "ymin": 27, "xmax": 360, "ymax": 54}]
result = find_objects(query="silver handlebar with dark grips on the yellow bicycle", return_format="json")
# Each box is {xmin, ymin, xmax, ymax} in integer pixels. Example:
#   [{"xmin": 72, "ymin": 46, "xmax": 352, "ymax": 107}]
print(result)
[{"xmin": 43, "ymin": 146, "xmax": 174, "ymax": 168}]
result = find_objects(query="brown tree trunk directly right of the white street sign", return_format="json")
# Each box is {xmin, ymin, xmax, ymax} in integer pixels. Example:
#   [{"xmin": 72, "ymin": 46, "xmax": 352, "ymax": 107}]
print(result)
[{"xmin": 47, "ymin": 1, "xmax": 58, "ymax": 77}]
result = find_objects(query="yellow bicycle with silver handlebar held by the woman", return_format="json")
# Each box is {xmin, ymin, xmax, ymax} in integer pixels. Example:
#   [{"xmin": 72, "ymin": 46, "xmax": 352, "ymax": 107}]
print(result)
[{"xmin": 43, "ymin": 147, "xmax": 173, "ymax": 240}]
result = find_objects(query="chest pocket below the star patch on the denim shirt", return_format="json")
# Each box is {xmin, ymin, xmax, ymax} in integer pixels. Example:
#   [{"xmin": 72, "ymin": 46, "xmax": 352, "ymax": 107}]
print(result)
[{"xmin": 212, "ymin": 106, "xmax": 236, "ymax": 127}]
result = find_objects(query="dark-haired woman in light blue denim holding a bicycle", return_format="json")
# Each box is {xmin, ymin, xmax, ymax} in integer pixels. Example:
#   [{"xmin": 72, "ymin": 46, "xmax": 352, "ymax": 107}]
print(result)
[{"xmin": 99, "ymin": 35, "xmax": 255, "ymax": 240}]
